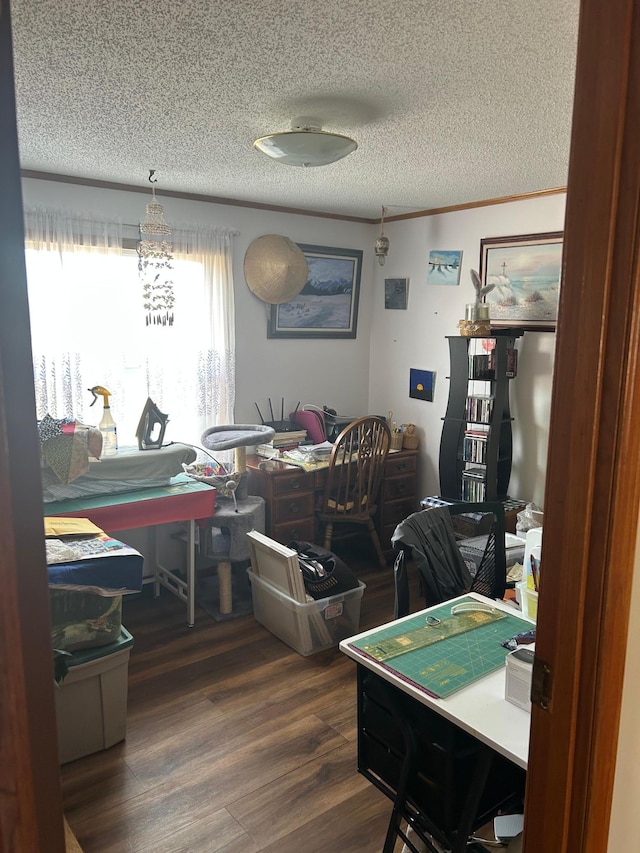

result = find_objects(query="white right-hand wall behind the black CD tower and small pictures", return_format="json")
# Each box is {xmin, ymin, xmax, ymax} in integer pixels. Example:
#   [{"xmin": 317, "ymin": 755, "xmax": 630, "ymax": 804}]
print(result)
[{"xmin": 369, "ymin": 194, "xmax": 565, "ymax": 506}]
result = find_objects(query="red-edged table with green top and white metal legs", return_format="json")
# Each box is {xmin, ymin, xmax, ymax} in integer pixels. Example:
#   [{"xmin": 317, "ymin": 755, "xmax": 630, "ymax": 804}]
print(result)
[{"xmin": 44, "ymin": 474, "xmax": 216, "ymax": 627}]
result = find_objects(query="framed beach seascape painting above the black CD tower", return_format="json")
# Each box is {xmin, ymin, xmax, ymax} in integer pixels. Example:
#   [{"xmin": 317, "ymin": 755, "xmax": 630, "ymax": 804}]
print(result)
[{"xmin": 480, "ymin": 231, "xmax": 563, "ymax": 332}]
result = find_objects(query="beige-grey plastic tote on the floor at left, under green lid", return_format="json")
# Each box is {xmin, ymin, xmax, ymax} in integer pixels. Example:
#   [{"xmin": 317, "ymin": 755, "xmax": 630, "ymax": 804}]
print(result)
[{"xmin": 55, "ymin": 628, "xmax": 133, "ymax": 764}]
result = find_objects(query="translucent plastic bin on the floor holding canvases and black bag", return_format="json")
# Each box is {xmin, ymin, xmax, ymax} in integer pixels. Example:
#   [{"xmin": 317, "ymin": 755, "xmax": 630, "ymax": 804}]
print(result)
[{"xmin": 247, "ymin": 569, "xmax": 366, "ymax": 655}]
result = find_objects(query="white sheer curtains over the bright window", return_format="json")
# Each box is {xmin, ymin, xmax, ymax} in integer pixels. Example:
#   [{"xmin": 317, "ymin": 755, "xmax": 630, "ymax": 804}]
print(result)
[{"xmin": 25, "ymin": 209, "xmax": 235, "ymax": 447}]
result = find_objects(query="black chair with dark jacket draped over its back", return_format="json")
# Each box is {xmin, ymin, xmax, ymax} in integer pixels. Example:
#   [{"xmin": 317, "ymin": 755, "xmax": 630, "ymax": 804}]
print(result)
[{"xmin": 391, "ymin": 502, "xmax": 507, "ymax": 619}]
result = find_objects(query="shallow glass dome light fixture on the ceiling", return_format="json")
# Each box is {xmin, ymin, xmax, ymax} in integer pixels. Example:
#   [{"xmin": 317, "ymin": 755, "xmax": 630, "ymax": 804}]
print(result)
[{"xmin": 253, "ymin": 120, "xmax": 358, "ymax": 168}]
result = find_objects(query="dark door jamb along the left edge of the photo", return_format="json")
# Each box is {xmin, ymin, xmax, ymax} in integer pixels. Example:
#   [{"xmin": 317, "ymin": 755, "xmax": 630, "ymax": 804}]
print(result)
[{"xmin": 0, "ymin": 0, "xmax": 65, "ymax": 853}]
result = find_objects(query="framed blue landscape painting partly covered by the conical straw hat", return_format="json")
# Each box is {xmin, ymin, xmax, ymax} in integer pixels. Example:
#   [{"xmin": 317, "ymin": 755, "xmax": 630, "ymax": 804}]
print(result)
[{"xmin": 267, "ymin": 243, "xmax": 362, "ymax": 338}]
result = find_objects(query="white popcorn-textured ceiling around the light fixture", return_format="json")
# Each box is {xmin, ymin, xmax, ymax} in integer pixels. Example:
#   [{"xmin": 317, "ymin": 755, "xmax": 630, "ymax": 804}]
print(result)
[{"xmin": 11, "ymin": 0, "xmax": 579, "ymax": 218}]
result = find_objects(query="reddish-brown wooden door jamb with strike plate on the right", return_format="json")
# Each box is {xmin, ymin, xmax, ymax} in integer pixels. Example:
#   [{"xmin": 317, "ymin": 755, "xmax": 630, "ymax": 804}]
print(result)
[{"xmin": 524, "ymin": 0, "xmax": 640, "ymax": 853}]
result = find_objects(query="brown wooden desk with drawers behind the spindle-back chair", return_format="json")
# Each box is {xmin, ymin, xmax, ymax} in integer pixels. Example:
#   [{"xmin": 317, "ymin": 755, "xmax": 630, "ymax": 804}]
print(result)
[{"xmin": 247, "ymin": 450, "xmax": 419, "ymax": 551}]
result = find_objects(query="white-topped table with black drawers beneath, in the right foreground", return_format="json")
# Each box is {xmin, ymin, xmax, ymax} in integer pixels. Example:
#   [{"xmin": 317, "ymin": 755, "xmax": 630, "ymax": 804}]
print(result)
[{"xmin": 340, "ymin": 594, "xmax": 531, "ymax": 853}]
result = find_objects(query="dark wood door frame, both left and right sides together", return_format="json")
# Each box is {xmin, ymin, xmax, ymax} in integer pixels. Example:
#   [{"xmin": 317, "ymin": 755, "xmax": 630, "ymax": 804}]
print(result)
[{"xmin": 0, "ymin": 0, "xmax": 640, "ymax": 853}]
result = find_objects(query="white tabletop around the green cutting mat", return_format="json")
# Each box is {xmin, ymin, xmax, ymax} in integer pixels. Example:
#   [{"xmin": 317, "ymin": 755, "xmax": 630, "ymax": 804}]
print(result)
[{"xmin": 340, "ymin": 593, "xmax": 535, "ymax": 769}]
